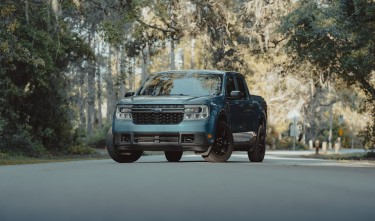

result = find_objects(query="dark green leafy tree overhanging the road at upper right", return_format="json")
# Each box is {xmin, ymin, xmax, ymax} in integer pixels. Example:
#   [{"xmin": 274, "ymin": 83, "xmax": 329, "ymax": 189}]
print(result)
[{"xmin": 280, "ymin": 0, "xmax": 375, "ymax": 146}]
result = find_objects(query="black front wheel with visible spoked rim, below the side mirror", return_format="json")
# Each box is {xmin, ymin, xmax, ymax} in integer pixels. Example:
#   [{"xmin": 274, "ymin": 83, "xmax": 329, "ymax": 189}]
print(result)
[{"xmin": 203, "ymin": 121, "xmax": 233, "ymax": 162}]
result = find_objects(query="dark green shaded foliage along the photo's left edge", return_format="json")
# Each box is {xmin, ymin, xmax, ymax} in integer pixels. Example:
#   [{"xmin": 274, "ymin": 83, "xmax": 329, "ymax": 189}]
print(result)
[{"xmin": 0, "ymin": 0, "xmax": 92, "ymax": 155}]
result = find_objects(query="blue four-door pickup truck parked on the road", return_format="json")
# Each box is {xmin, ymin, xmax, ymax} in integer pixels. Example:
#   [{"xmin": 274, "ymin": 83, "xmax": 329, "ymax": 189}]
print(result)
[{"xmin": 106, "ymin": 70, "xmax": 267, "ymax": 163}]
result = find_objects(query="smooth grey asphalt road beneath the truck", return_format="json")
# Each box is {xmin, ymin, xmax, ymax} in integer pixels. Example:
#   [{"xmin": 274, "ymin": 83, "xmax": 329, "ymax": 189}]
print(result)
[{"xmin": 0, "ymin": 152, "xmax": 375, "ymax": 221}]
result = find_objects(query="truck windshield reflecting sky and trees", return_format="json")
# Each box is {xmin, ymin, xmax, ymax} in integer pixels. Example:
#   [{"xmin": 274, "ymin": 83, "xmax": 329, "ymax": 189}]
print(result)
[{"xmin": 138, "ymin": 73, "xmax": 223, "ymax": 96}]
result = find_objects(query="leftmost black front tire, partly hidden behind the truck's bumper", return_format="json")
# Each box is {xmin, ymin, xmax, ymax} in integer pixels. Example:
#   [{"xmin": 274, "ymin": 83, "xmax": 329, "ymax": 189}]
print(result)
[{"xmin": 106, "ymin": 128, "xmax": 143, "ymax": 163}]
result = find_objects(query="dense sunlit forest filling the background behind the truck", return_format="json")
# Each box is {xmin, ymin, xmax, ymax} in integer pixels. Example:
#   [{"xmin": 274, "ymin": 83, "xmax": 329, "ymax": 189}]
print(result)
[{"xmin": 0, "ymin": 0, "xmax": 375, "ymax": 156}]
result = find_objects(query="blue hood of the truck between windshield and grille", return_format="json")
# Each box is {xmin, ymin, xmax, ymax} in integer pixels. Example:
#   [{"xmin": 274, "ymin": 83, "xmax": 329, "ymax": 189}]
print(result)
[{"xmin": 119, "ymin": 96, "xmax": 215, "ymax": 104}]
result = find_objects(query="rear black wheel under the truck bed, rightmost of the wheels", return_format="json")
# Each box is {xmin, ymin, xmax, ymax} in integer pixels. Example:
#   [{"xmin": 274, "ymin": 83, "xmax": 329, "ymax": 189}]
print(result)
[{"xmin": 247, "ymin": 124, "xmax": 266, "ymax": 162}]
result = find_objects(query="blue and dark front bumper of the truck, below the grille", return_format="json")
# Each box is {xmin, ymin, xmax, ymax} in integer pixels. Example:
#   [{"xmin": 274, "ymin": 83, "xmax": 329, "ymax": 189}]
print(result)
[{"xmin": 113, "ymin": 120, "xmax": 214, "ymax": 152}]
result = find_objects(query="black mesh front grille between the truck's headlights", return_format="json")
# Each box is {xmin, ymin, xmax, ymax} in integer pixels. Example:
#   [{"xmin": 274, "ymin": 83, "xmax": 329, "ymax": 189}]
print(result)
[{"xmin": 132, "ymin": 104, "xmax": 184, "ymax": 125}]
